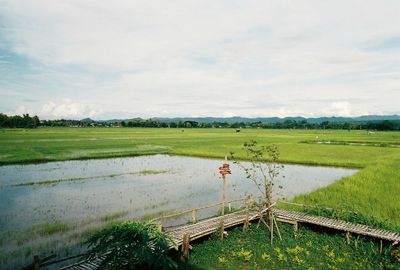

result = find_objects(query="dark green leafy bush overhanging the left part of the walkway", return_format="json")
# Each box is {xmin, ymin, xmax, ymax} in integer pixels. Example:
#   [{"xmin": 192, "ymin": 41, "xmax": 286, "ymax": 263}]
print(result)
[{"xmin": 88, "ymin": 221, "xmax": 177, "ymax": 270}]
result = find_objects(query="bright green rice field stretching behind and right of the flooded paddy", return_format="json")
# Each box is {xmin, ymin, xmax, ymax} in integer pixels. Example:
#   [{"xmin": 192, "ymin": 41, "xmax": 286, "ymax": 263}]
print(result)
[{"xmin": 0, "ymin": 128, "xmax": 400, "ymax": 230}]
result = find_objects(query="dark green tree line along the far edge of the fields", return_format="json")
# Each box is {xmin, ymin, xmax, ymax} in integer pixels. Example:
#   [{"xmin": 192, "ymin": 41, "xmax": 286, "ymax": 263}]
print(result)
[{"xmin": 0, "ymin": 113, "xmax": 400, "ymax": 131}]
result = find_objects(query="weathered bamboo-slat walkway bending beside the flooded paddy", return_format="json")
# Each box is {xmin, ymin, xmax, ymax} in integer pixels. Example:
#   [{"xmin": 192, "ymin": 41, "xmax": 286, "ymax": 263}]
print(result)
[{"xmin": 61, "ymin": 209, "xmax": 400, "ymax": 270}]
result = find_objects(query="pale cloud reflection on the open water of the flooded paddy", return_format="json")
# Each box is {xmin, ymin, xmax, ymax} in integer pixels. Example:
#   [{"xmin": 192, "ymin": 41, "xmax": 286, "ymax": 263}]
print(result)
[{"xmin": 0, "ymin": 155, "xmax": 355, "ymax": 230}]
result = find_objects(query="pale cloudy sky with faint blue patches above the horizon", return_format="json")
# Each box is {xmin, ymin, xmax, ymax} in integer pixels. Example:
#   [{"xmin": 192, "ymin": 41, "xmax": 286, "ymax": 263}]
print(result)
[{"xmin": 0, "ymin": 0, "xmax": 400, "ymax": 119}]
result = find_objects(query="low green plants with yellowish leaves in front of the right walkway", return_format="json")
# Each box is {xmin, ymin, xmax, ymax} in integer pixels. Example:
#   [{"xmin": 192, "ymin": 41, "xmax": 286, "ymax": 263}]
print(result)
[{"xmin": 189, "ymin": 225, "xmax": 400, "ymax": 270}]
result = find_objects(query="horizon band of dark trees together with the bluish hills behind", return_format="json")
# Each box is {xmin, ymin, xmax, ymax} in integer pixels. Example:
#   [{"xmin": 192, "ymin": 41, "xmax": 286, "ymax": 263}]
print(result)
[{"xmin": 0, "ymin": 113, "xmax": 400, "ymax": 131}]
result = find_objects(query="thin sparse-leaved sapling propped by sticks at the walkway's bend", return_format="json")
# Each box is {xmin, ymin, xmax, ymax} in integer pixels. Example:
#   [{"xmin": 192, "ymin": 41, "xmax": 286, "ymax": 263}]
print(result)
[{"xmin": 231, "ymin": 140, "xmax": 283, "ymax": 243}]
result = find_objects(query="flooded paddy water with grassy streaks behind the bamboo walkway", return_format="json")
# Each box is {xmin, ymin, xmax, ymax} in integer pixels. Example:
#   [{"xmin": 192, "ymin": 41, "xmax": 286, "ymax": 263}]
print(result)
[{"xmin": 0, "ymin": 155, "xmax": 356, "ymax": 269}]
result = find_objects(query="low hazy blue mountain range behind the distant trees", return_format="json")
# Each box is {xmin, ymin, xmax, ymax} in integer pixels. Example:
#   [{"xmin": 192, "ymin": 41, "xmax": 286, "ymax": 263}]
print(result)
[{"xmin": 85, "ymin": 115, "xmax": 400, "ymax": 124}]
